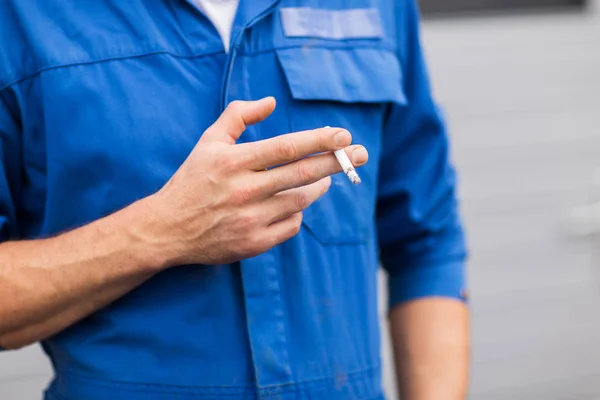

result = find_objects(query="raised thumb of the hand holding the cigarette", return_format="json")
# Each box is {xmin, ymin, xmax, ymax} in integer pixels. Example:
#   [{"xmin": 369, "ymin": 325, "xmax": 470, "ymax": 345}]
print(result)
[{"xmin": 201, "ymin": 97, "xmax": 275, "ymax": 144}]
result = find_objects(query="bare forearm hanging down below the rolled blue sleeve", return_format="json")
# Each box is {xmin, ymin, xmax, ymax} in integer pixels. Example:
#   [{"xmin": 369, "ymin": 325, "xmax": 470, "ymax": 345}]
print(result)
[{"xmin": 390, "ymin": 297, "xmax": 470, "ymax": 400}]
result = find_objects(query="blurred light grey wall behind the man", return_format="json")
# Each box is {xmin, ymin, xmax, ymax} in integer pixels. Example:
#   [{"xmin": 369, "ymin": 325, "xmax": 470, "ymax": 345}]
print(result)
[{"xmin": 0, "ymin": 0, "xmax": 600, "ymax": 400}]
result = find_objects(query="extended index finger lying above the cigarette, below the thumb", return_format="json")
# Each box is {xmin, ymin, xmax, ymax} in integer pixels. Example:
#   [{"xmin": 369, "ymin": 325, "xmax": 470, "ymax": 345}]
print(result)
[{"xmin": 231, "ymin": 128, "xmax": 352, "ymax": 171}]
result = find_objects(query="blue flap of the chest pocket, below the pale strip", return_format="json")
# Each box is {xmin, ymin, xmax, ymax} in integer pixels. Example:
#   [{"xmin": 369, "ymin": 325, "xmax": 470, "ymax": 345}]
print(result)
[{"xmin": 277, "ymin": 47, "xmax": 406, "ymax": 105}]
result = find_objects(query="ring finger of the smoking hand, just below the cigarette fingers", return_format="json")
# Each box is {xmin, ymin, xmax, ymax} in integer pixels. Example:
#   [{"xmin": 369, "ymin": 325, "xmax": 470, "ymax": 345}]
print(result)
[{"xmin": 261, "ymin": 177, "xmax": 331, "ymax": 225}]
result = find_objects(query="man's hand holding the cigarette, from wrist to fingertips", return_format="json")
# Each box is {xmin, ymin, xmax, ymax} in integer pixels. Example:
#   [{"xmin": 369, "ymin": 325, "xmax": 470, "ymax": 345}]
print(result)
[{"xmin": 154, "ymin": 98, "xmax": 367, "ymax": 264}]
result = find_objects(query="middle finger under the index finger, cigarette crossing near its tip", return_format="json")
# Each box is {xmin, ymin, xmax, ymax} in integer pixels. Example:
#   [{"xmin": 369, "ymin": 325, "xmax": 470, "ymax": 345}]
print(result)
[{"xmin": 254, "ymin": 145, "xmax": 369, "ymax": 196}]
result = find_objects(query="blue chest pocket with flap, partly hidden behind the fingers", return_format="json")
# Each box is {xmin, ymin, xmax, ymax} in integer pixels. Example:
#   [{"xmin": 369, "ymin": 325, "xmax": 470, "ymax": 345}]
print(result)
[{"xmin": 277, "ymin": 46, "xmax": 406, "ymax": 244}]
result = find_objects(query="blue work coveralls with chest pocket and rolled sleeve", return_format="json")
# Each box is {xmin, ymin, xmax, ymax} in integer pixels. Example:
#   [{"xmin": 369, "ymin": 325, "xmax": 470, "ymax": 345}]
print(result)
[{"xmin": 0, "ymin": 0, "xmax": 465, "ymax": 400}]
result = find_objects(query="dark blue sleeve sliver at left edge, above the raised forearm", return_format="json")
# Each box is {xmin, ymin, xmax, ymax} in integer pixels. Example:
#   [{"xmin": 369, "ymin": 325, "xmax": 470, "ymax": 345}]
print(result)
[{"xmin": 0, "ymin": 89, "xmax": 21, "ymax": 243}]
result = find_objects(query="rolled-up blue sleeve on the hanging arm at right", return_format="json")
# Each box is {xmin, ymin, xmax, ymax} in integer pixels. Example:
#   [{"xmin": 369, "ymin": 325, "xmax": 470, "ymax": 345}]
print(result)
[{"xmin": 377, "ymin": 0, "xmax": 466, "ymax": 308}]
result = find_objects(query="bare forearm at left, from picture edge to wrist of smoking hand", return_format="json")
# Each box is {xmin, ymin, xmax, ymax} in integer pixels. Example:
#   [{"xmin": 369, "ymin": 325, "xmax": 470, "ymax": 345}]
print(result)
[{"xmin": 0, "ymin": 194, "xmax": 172, "ymax": 348}]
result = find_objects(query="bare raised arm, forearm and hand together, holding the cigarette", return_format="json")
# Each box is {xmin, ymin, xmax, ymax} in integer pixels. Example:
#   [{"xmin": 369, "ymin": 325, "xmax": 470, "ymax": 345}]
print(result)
[{"xmin": 0, "ymin": 98, "xmax": 367, "ymax": 348}]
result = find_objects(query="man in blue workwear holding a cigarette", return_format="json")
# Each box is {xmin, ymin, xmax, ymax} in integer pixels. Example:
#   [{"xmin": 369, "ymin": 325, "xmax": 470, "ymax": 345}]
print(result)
[{"xmin": 0, "ymin": 0, "xmax": 468, "ymax": 400}]
